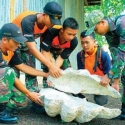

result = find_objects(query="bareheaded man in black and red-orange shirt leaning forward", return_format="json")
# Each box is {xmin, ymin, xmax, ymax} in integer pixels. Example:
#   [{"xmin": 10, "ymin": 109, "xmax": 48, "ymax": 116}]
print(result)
[{"xmin": 40, "ymin": 17, "xmax": 78, "ymax": 85}]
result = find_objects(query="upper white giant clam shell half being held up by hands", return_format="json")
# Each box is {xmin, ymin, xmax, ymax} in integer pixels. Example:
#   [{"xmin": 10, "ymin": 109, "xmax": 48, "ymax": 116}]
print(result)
[{"xmin": 47, "ymin": 68, "xmax": 121, "ymax": 98}]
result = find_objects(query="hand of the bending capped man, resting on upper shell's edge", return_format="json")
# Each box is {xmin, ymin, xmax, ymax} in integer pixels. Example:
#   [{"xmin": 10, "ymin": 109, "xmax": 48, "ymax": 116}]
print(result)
[{"xmin": 49, "ymin": 64, "xmax": 62, "ymax": 78}]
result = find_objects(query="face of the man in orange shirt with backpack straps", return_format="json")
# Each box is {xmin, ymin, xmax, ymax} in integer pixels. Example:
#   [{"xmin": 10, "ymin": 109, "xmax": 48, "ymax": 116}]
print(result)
[{"xmin": 80, "ymin": 36, "xmax": 96, "ymax": 52}]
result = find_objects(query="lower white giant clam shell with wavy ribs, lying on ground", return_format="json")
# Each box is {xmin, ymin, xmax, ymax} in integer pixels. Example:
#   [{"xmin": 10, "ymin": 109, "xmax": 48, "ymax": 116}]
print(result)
[{"xmin": 40, "ymin": 88, "xmax": 121, "ymax": 123}]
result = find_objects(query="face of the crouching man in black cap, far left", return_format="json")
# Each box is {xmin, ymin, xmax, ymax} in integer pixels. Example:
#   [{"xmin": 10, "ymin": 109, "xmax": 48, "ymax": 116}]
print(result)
[{"xmin": 3, "ymin": 38, "xmax": 20, "ymax": 51}]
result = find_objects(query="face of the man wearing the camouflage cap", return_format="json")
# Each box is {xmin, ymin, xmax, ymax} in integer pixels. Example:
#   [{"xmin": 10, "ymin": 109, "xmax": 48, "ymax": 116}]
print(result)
[{"xmin": 95, "ymin": 20, "xmax": 108, "ymax": 35}]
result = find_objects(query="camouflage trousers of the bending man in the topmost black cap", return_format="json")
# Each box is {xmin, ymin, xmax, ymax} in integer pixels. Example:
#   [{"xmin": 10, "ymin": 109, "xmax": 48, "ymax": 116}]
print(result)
[{"xmin": 13, "ymin": 50, "xmax": 39, "ymax": 92}]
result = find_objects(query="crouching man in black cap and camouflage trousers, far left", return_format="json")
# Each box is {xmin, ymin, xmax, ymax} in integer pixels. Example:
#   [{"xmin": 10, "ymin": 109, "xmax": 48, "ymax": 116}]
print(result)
[{"xmin": 0, "ymin": 23, "xmax": 48, "ymax": 124}]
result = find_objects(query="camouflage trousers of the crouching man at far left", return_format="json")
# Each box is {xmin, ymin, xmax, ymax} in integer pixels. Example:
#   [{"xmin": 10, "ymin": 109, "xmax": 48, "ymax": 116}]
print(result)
[{"xmin": 0, "ymin": 67, "xmax": 27, "ymax": 108}]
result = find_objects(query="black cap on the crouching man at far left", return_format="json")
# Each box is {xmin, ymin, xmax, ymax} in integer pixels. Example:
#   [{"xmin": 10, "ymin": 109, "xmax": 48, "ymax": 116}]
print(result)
[{"xmin": 0, "ymin": 23, "xmax": 27, "ymax": 43}]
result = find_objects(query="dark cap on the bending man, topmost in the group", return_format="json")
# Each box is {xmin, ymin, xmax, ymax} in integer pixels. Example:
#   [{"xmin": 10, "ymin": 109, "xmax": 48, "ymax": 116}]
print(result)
[{"xmin": 43, "ymin": 1, "xmax": 62, "ymax": 25}]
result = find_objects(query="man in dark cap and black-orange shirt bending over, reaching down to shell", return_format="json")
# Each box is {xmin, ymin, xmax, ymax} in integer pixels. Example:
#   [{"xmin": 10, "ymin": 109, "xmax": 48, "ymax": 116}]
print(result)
[{"xmin": 12, "ymin": 2, "xmax": 62, "ymax": 91}]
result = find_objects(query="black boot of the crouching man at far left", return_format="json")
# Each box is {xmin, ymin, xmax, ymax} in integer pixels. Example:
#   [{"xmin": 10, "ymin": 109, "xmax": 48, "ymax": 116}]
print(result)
[{"xmin": 0, "ymin": 103, "xmax": 18, "ymax": 124}]
